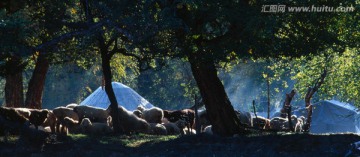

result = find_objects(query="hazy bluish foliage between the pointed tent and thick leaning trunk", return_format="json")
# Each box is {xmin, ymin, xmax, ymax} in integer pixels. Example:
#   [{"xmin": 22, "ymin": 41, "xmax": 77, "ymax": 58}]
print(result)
[{"xmin": 136, "ymin": 59, "xmax": 199, "ymax": 109}]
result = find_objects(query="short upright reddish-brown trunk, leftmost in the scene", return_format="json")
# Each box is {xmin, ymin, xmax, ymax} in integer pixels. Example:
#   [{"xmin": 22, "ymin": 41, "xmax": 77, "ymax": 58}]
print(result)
[{"xmin": 5, "ymin": 71, "xmax": 24, "ymax": 107}]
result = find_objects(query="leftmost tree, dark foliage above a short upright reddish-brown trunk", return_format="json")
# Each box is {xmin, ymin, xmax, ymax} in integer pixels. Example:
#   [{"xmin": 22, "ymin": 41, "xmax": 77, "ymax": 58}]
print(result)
[{"xmin": 0, "ymin": 10, "xmax": 33, "ymax": 107}]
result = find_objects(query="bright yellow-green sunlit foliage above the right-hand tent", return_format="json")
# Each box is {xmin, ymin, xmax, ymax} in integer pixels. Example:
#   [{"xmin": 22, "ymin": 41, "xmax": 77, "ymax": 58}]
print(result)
[{"xmin": 262, "ymin": 48, "xmax": 360, "ymax": 105}]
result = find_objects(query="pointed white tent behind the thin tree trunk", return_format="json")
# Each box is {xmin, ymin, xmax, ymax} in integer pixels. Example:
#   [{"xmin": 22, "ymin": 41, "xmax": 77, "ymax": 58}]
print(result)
[{"xmin": 80, "ymin": 82, "xmax": 153, "ymax": 111}]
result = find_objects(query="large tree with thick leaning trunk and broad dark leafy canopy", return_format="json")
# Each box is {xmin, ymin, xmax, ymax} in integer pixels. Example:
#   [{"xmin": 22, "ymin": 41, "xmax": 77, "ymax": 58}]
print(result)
[{"xmin": 143, "ymin": 0, "xmax": 358, "ymax": 136}]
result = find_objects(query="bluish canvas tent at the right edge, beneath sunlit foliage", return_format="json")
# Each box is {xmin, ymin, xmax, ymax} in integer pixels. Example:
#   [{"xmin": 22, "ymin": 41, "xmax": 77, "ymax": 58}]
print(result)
[{"xmin": 294, "ymin": 100, "xmax": 360, "ymax": 133}]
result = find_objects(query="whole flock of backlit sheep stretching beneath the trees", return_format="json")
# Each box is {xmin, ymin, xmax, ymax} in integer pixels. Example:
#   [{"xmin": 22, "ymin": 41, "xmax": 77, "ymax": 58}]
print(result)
[{"xmin": 0, "ymin": 104, "xmax": 305, "ymax": 139}]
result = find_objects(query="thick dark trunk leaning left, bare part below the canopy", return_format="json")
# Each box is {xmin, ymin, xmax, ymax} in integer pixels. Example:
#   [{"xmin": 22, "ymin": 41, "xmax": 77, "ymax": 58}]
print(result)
[{"xmin": 188, "ymin": 54, "xmax": 243, "ymax": 136}]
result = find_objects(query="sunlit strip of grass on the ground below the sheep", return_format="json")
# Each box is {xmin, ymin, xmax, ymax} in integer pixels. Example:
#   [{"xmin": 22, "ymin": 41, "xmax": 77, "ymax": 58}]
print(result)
[{"xmin": 69, "ymin": 134, "xmax": 178, "ymax": 147}]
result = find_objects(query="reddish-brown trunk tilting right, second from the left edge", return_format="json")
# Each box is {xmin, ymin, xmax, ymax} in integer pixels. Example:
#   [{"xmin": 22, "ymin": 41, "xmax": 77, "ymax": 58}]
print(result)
[{"xmin": 25, "ymin": 55, "xmax": 50, "ymax": 109}]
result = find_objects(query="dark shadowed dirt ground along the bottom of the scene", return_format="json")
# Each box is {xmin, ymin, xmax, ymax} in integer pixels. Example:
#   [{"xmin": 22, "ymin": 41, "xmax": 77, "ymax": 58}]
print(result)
[{"xmin": 0, "ymin": 134, "xmax": 360, "ymax": 157}]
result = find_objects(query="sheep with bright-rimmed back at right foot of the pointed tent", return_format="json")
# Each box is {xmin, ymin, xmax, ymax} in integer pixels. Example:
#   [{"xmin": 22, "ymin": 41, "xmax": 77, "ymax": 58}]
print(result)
[{"xmin": 137, "ymin": 106, "xmax": 164, "ymax": 123}]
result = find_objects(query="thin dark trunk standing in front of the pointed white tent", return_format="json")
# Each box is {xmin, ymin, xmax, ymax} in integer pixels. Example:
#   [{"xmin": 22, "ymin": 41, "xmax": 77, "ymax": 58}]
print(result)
[{"xmin": 99, "ymin": 37, "xmax": 124, "ymax": 133}]
